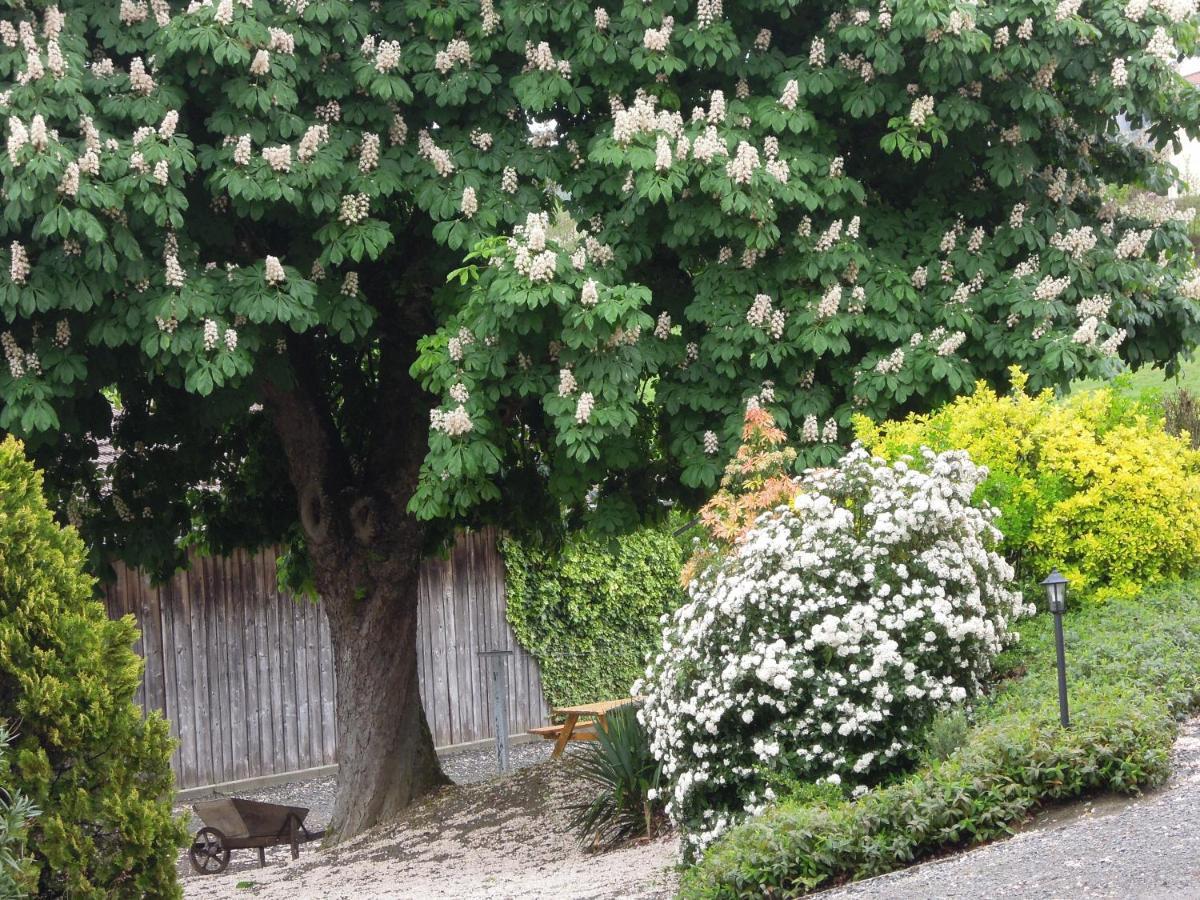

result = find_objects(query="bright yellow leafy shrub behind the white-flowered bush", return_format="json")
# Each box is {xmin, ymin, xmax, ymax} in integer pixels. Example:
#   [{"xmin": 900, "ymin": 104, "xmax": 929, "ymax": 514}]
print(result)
[{"xmin": 856, "ymin": 371, "xmax": 1200, "ymax": 599}]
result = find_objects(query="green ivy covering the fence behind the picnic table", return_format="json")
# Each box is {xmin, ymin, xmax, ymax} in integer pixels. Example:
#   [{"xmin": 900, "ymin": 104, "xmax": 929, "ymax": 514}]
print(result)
[{"xmin": 500, "ymin": 526, "xmax": 684, "ymax": 706}]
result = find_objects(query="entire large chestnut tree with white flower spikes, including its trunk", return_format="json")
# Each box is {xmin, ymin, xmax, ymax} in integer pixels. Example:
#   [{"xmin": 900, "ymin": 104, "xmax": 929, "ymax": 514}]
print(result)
[{"xmin": 0, "ymin": 0, "xmax": 1200, "ymax": 835}]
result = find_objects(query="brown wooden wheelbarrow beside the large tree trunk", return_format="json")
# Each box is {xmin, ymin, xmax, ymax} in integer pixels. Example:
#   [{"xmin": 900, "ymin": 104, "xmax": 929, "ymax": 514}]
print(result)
[{"xmin": 187, "ymin": 797, "xmax": 325, "ymax": 875}]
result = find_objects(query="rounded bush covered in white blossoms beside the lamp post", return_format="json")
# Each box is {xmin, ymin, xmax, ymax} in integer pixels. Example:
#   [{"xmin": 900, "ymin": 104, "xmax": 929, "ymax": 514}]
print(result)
[{"xmin": 641, "ymin": 445, "xmax": 1026, "ymax": 854}]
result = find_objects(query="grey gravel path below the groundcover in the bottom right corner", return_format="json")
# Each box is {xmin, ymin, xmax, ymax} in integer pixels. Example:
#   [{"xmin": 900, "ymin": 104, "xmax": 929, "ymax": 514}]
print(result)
[{"xmin": 817, "ymin": 719, "xmax": 1200, "ymax": 900}]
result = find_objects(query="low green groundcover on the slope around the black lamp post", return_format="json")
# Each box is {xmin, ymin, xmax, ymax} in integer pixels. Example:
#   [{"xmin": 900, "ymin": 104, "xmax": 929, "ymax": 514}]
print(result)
[{"xmin": 679, "ymin": 582, "xmax": 1200, "ymax": 900}]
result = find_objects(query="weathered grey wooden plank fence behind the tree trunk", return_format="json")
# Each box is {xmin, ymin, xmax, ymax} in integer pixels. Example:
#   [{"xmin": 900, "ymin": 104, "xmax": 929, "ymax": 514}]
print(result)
[{"xmin": 107, "ymin": 532, "xmax": 546, "ymax": 788}]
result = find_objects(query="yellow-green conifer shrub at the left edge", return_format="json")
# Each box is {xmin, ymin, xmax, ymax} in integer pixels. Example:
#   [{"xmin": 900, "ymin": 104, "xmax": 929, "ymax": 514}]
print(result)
[{"xmin": 0, "ymin": 438, "xmax": 185, "ymax": 898}]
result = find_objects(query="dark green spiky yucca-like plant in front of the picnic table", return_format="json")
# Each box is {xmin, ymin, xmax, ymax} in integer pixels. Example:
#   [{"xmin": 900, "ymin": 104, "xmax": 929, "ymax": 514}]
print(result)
[{"xmin": 570, "ymin": 704, "xmax": 666, "ymax": 847}]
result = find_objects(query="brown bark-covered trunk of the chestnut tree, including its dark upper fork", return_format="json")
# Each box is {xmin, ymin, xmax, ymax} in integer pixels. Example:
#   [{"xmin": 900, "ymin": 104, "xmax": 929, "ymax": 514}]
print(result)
[{"xmin": 264, "ymin": 368, "xmax": 448, "ymax": 840}]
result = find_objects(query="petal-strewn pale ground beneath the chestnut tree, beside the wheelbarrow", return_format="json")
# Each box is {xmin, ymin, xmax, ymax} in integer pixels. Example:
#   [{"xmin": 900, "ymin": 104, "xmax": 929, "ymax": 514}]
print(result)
[{"xmin": 184, "ymin": 760, "xmax": 678, "ymax": 900}]
